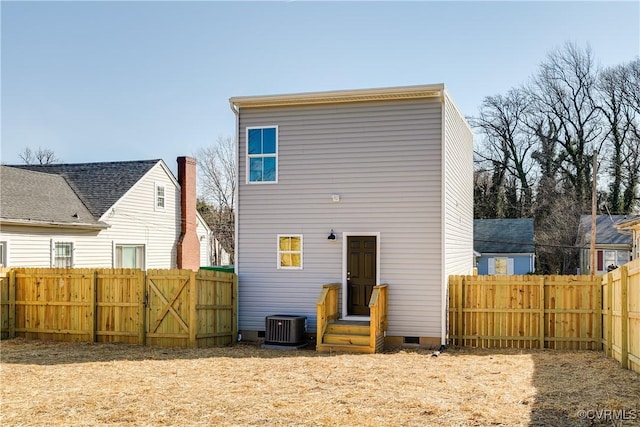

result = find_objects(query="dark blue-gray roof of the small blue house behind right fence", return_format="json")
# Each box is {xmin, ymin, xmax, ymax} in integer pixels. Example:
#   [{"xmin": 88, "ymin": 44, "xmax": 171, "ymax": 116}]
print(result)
[{"xmin": 473, "ymin": 218, "xmax": 535, "ymax": 253}]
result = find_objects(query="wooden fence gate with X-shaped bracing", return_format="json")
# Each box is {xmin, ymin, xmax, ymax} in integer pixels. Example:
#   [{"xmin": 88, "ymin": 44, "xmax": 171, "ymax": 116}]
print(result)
[{"xmin": 146, "ymin": 270, "xmax": 196, "ymax": 347}]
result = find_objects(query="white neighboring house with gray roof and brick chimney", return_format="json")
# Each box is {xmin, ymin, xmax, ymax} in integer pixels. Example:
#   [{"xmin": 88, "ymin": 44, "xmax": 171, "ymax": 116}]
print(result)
[{"xmin": 0, "ymin": 157, "xmax": 215, "ymax": 270}]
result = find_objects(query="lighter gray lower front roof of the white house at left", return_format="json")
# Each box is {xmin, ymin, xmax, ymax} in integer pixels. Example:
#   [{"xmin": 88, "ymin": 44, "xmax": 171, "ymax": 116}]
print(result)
[{"xmin": 0, "ymin": 166, "xmax": 108, "ymax": 229}]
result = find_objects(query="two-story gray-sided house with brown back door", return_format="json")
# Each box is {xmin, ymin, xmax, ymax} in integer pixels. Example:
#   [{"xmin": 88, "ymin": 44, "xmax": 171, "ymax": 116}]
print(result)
[{"xmin": 230, "ymin": 84, "xmax": 473, "ymax": 345}]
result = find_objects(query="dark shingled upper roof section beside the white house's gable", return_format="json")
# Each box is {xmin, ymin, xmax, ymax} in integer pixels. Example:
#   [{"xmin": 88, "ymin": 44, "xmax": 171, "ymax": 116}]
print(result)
[{"xmin": 15, "ymin": 159, "xmax": 162, "ymax": 218}]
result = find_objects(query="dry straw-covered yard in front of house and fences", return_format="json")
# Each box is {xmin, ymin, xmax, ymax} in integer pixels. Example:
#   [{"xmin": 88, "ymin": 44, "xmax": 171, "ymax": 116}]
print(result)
[{"xmin": 0, "ymin": 339, "xmax": 640, "ymax": 426}]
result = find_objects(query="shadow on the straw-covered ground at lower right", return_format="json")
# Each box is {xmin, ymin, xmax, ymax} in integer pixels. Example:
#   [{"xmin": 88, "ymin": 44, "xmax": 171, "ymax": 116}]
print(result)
[{"xmin": 448, "ymin": 348, "xmax": 640, "ymax": 427}]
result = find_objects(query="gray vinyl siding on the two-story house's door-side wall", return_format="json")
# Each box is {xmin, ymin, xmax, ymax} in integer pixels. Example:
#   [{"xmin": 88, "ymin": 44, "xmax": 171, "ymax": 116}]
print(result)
[{"xmin": 236, "ymin": 99, "xmax": 442, "ymax": 337}]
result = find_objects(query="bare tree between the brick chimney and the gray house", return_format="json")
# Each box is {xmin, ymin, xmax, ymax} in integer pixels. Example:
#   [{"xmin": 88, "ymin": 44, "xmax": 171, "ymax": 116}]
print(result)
[{"xmin": 196, "ymin": 136, "xmax": 238, "ymax": 264}]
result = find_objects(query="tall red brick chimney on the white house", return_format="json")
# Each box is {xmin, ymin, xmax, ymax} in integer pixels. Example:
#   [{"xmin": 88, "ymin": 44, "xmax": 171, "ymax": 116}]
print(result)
[{"xmin": 177, "ymin": 157, "xmax": 200, "ymax": 270}]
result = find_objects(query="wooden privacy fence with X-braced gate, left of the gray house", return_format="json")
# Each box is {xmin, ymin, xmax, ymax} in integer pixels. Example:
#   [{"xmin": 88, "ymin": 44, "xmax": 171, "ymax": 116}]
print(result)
[{"xmin": 0, "ymin": 268, "xmax": 237, "ymax": 347}]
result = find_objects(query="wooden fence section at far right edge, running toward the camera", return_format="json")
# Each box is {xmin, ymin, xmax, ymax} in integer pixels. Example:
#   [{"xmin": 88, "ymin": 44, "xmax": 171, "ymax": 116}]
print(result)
[{"xmin": 602, "ymin": 259, "xmax": 640, "ymax": 373}]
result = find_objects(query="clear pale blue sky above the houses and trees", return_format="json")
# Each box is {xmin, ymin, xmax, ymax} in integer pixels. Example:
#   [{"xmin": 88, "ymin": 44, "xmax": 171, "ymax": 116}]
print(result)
[{"xmin": 0, "ymin": 1, "xmax": 640, "ymax": 170}]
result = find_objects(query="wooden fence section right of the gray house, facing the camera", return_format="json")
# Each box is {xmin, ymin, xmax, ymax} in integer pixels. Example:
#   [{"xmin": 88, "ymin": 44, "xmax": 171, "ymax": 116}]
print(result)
[{"xmin": 449, "ymin": 276, "xmax": 602, "ymax": 350}]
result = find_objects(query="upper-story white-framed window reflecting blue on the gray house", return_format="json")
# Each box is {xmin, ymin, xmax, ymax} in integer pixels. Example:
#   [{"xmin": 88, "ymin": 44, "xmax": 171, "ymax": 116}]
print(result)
[{"xmin": 247, "ymin": 126, "xmax": 278, "ymax": 183}]
